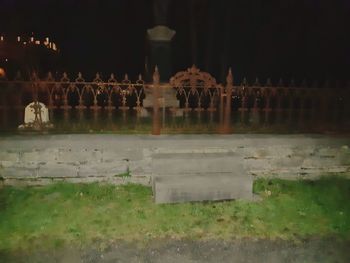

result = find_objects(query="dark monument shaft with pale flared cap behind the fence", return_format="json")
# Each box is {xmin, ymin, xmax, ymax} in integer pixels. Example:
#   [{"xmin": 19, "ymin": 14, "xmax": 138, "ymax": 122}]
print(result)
[{"xmin": 147, "ymin": 26, "xmax": 176, "ymax": 82}]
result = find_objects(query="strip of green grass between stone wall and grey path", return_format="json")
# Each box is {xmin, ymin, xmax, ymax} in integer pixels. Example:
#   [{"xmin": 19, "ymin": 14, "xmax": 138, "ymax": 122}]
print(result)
[{"xmin": 0, "ymin": 178, "xmax": 350, "ymax": 250}]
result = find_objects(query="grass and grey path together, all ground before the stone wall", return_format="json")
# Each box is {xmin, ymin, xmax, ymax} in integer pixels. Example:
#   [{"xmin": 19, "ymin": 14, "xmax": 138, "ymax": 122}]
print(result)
[{"xmin": 0, "ymin": 177, "xmax": 350, "ymax": 262}]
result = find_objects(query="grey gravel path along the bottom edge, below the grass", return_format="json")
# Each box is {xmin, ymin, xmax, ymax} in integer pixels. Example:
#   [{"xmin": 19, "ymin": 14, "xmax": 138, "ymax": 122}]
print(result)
[{"xmin": 0, "ymin": 239, "xmax": 350, "ymax": 263}]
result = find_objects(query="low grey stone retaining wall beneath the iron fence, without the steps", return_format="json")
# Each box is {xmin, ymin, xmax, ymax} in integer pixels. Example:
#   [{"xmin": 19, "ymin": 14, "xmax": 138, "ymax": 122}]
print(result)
[{"xmin": 0, "ymin": 135, "xmax": 350, "ymax": 185}]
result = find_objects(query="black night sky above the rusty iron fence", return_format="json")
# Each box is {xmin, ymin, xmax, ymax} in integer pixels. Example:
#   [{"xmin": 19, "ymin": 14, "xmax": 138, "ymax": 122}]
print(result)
[{"xmin": 0, "ymin": 0, "xmax": 350, "ymax": 83}]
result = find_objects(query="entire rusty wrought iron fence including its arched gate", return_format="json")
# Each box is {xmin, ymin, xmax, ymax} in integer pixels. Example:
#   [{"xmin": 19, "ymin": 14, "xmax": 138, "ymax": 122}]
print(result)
[{"xmin": 0, "ymin": 66, "xmax": 350, "ymax": 134}]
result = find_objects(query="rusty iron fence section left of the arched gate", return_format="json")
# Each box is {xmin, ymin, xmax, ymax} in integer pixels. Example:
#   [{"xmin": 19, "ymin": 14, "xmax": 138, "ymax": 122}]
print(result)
[{"xmin": 0, "ymin": 73, "xmax": 145, "ymax": 110}]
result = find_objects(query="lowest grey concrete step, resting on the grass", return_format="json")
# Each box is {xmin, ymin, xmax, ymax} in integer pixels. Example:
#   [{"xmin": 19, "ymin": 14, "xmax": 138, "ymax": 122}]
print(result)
[{"xmin": 152, "ymin": 173, "xmax": 253, "ymax": 204}]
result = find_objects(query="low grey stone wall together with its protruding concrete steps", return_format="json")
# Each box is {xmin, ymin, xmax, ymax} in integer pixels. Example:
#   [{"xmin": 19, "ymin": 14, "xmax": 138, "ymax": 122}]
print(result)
[{"xmin": 0, "ymin": 134, "xmax": 350, "ymax": 202}]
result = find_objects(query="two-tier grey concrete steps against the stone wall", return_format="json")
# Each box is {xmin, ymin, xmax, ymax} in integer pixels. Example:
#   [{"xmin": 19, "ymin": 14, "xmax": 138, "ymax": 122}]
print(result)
[{"xmin": 152, "ymin": 149, "xmax": 253, "ymax": 204}]
